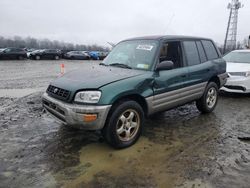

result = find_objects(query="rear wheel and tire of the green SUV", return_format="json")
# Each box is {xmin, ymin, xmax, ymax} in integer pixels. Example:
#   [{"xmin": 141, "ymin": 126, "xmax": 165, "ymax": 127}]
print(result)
[{"xmin": 196, "ymin": 82, "xmax": 219, "ymax": 113}]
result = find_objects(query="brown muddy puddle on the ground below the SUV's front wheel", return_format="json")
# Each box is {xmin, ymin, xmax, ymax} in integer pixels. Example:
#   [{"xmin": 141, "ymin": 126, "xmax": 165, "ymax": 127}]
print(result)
[{"xmin": 55, "ymin": 137, "xmax": 199, "ymax": 187}]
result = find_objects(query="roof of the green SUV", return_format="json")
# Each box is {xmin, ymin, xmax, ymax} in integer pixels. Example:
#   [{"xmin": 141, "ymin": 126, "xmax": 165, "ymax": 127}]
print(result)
[{"xmin": 125, "ymin": 35, "xmax": 211, "ymax": 41}]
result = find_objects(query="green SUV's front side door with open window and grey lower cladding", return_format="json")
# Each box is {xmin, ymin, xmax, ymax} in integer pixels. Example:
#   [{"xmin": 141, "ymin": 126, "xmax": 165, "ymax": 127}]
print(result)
[{"xmin": 152, "ymin": 41, "xmax": 188, "ymax": 112}]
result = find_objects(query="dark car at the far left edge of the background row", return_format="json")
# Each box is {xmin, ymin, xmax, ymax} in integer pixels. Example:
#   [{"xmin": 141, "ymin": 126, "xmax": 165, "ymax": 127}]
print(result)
[{"xmin": 0, "ymin": 48, "xmax": 27, "ymax": 60}]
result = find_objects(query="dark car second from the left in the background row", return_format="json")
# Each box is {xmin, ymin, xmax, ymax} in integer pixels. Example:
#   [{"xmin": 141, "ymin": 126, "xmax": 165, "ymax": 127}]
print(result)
[{"xmin": 29, "ymin": 49, "xmax": 62, "ymax": 60}]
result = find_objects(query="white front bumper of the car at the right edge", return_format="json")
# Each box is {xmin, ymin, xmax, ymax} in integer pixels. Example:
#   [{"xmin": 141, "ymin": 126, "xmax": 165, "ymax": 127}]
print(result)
[{"xmin": 221, "ymin": 76, "xmax": 250, "ymax": 93}]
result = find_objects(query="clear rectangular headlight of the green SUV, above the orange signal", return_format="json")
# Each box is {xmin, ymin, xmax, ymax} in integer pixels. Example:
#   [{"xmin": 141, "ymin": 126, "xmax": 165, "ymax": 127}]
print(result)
[{"xmin": 75, "ymin": 91, "xmax": 102, "ymax": 104}]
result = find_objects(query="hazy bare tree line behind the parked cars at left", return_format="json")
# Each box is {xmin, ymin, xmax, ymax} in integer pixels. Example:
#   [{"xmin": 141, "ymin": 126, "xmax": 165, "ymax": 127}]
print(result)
[{"xmin": 0, "ymin": 36, "xmax": 110, "ymax": 51}]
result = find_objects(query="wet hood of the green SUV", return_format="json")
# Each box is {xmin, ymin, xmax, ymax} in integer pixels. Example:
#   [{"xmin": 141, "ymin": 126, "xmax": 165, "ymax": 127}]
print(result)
[{"xmin": 51, "ymin": 64, "xmax": 145, "ymax": 92}]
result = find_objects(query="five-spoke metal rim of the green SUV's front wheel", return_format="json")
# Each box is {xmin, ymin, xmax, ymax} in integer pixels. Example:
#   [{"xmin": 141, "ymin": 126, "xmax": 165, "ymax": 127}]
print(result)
[{"xmin": 116, "ymin": 109, "xmax": 141, "ymax": 141}]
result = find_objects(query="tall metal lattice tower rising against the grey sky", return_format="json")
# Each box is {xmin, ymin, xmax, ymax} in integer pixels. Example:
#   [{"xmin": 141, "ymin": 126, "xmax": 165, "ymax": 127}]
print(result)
[{"xmin": 223, "ymin": 0, "xmax": 243, "ymax": 53}]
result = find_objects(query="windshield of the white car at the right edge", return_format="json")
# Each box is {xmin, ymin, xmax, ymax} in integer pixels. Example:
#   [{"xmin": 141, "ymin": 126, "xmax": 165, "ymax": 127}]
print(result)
[{"xmin": 223, "ymin": 51, "xmax": 250, "ymax": 63}]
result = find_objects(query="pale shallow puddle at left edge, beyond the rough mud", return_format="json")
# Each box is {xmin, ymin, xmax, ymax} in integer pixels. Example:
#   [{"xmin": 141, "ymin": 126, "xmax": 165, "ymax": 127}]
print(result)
[{"xmin": 0, "ymin": 87, "xmax": 46, "ymax": 98}]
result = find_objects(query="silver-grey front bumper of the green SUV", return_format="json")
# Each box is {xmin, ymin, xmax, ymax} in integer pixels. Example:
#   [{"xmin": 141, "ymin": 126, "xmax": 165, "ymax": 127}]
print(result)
[{"xmin": 42, "ymin": 93, "xmax": 111, "ymax": 130}]
